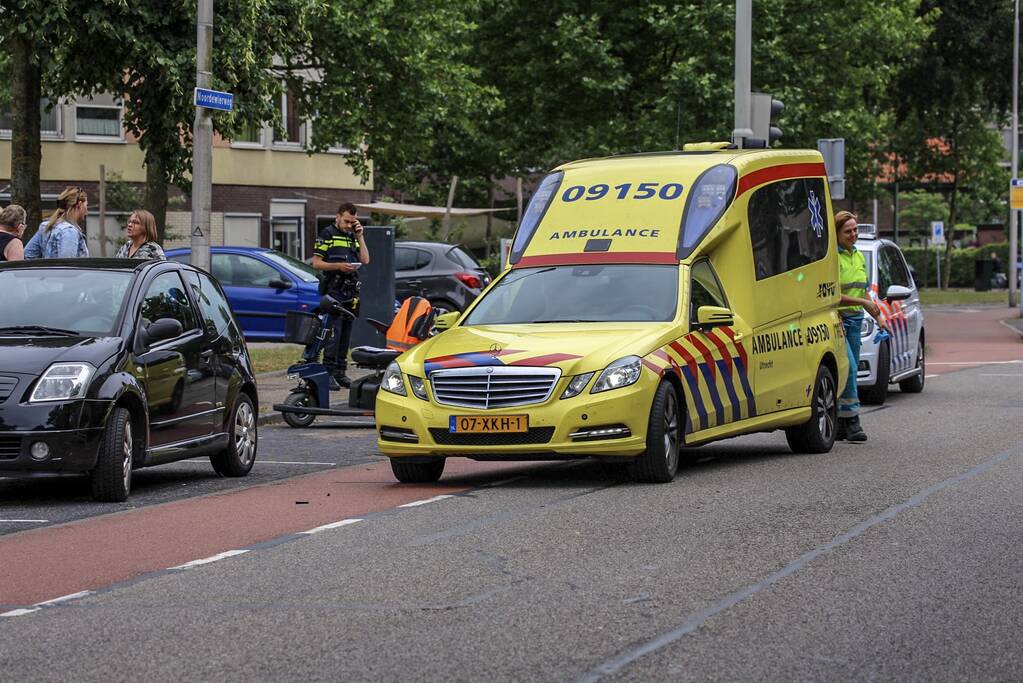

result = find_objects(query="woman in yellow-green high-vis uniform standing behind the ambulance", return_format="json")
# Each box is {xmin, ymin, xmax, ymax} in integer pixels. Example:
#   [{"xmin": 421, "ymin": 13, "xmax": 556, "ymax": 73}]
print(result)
[{"xmin": 835, "ymin": 211, "xmax": 888, "ymax": 442}]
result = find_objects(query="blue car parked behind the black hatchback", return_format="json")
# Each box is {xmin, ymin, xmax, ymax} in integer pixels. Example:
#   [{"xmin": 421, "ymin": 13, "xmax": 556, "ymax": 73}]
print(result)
[{"xmin": 167, "ymin": 246, "xmax": 320, "ymax": 342}]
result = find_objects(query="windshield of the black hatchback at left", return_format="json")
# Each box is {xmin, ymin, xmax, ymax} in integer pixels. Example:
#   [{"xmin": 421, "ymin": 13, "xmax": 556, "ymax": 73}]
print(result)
[{"xmin": 0, "ymin": 268, "xmax": 134, "ymax": 336}]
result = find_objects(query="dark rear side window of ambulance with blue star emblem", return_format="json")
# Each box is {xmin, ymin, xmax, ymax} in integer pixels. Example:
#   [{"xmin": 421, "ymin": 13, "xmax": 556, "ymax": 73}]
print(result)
[{"xmin": 749, "ymin": 178, "xmax": 829, "ymax": 280}]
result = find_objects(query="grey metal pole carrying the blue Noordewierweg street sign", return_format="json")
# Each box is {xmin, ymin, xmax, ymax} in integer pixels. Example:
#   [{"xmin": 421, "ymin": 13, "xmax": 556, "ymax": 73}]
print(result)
[{"xmin": 191, "ymin": 0, "xmax": 213, "ymax": 271}]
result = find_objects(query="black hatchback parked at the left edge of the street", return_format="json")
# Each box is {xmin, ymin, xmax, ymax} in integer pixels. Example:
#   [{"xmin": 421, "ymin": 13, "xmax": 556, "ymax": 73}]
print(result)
[{"xmin": 0, "ymin": 259, "xmax": 258, "ymax": 501}]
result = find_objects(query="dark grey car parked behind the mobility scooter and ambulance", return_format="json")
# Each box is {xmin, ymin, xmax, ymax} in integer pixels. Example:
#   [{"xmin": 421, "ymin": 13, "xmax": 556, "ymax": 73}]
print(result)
[{"xmin": 394, "ymin": 242, "xmax": 490, "ymax": 313}]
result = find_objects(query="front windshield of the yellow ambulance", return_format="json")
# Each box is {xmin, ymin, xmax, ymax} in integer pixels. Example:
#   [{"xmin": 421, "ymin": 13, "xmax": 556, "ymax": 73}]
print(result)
[{"xmin": 464, "ymin": 265, "xmax": 678, "ymax": 325}]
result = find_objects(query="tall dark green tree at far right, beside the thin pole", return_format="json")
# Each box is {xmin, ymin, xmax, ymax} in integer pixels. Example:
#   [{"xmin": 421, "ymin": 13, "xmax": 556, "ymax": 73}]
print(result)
[{"xmin": 897, "ymin": 0, "xmax": 1013, "ymax": 287}]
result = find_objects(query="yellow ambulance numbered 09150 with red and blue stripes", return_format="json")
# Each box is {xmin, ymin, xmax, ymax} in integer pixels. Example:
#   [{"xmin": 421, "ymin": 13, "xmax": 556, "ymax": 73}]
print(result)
[{"xmin": 376, "ymin": 143, "xmax": 848, "ymax": 483}]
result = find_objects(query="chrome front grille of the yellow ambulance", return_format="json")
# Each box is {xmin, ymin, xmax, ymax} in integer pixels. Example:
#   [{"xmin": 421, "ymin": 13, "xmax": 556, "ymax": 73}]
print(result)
[{"xmin": 430, "ymin": 366, "xmax": 562, "ymax": 410}]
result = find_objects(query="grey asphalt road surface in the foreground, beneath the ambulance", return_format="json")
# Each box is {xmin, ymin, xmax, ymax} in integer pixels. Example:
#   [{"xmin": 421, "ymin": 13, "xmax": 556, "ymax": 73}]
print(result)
[{"xmin": 0, "ymin": 351, "xmax": 1023, "ymax": 681}]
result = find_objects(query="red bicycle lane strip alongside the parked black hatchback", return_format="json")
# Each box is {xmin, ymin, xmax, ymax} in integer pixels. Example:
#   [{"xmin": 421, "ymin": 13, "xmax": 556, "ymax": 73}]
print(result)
[{"xmin": 0, "ymin": 459, "xmax": 537, "ymax": 609}]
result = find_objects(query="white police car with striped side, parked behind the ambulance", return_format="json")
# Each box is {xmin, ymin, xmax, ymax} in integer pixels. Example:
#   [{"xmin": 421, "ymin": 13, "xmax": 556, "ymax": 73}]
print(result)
[{"xmin": 856, "ymin": 224, "xmax": 926, "ymax": 405}]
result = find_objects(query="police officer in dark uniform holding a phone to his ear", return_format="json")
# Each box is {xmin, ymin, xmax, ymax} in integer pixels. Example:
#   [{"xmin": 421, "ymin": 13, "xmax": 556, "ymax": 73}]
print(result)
[{"xmin": 312, "ymin": 201, "xmax": 369, "ymax": 391}]
